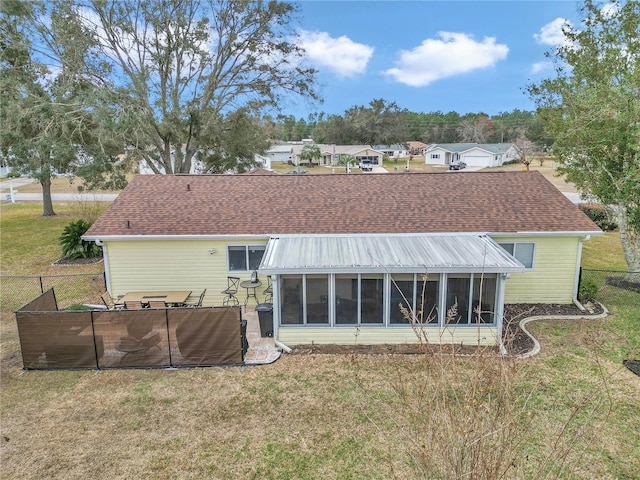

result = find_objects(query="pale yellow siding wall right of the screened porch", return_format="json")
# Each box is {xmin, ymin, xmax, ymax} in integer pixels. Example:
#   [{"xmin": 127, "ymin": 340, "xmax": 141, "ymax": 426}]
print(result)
[{"xmin": 494, "ymin": 237, "xmax": 580, "ymax": 303}]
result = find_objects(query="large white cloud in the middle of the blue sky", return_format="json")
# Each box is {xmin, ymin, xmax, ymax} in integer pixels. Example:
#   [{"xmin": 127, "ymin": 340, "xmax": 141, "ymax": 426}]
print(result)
[{"xmin": 383, "ymin": 32, "xmax": 509, "ymax": 87}]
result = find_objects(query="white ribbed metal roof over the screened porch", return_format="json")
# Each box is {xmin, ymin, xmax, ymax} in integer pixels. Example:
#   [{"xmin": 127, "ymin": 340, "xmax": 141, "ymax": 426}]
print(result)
[{"xmin": 260, "ymin": 235, "xmax": 524, "ymax": 273}]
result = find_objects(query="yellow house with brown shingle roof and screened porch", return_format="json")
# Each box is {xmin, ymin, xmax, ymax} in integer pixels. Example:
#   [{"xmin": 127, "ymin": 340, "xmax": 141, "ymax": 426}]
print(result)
[{"xmin": 83, "ymin": 171, "xmax": 602, "ymax": 345}]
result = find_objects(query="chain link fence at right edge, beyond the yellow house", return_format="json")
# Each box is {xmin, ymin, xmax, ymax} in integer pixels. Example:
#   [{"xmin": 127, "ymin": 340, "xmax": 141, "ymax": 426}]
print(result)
[{"xmin": 578, "ymin": 268, "xmax": 640, "ymax": 308}]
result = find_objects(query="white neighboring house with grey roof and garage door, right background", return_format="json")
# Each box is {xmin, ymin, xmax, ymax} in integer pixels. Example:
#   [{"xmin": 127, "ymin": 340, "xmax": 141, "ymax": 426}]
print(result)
[{"xmin": 424, "ymin": 143, "xmax": 518, "ymax": 167}]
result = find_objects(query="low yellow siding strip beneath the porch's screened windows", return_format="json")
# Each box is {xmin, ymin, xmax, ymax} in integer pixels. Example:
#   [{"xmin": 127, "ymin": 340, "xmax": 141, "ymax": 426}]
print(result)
[{"xmin": 278, "ymin": 327, "xmax": 498, "ymax": 345}]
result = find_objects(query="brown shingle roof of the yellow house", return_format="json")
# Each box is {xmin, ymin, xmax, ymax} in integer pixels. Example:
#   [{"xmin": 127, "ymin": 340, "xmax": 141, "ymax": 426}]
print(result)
[{"xmin": 86, "ymin": 172, "xmax": 599, "ymax": 238}]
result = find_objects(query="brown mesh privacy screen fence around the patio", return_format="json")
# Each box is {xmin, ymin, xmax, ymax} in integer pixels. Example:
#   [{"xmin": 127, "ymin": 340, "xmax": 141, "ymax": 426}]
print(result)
[{"xmin": 16, "ymin": 291, "xmax": 246, "ymax": 369}]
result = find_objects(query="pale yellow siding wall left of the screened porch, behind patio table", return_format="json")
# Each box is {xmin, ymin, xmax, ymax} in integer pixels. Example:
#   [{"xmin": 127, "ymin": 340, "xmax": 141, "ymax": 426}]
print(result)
[{"xmin": 107, "ymin": 239, "xmax": 267, "ymax": 305}]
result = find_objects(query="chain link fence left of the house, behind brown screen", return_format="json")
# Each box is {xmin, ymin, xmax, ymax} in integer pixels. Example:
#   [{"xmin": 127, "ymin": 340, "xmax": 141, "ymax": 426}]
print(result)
[{"xmin": 0, "ymin": 272, "xmax": 106, "ymax": 313}]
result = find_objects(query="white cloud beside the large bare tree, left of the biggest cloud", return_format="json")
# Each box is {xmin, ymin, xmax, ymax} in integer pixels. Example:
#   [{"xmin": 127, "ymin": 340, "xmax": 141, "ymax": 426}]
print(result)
[{"xmin": 299, "ymin": 30, "xmax": 374, "ymax": 77}]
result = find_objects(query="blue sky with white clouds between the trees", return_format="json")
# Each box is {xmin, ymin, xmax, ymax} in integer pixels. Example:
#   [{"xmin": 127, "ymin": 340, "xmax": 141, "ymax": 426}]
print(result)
[{"xmin": 283, "ymin": 0, "xmax": 580, "ymax": 118}]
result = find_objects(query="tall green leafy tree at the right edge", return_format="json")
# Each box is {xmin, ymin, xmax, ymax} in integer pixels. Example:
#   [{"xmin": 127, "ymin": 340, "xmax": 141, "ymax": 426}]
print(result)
[{"xmin": 527, "ymin": 0, "xmax": 640, "ymax": 283}]
